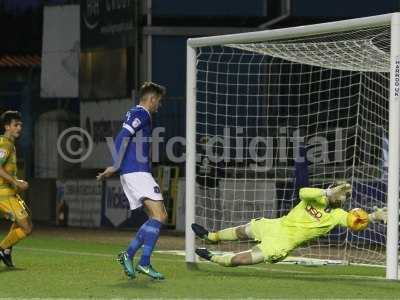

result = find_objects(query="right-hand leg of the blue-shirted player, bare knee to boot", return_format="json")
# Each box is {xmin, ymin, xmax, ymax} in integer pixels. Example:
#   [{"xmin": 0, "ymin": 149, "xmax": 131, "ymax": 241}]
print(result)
[{"xmin": 136, "ymin": 198, "xmax": 168, "ymax": 279}]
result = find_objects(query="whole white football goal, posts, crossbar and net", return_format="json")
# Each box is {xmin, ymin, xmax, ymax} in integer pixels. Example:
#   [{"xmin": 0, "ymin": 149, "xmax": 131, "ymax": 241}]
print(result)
[{"xmin": 186, "ymin": 13, "xmax": 400, "ymax": 279}]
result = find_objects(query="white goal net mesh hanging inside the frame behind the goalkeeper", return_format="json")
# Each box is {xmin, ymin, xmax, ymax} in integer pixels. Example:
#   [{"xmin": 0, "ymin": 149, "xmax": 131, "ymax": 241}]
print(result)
[{"xmin": 195, "ymin": 26, "xmax": 390, "ymax": 264}]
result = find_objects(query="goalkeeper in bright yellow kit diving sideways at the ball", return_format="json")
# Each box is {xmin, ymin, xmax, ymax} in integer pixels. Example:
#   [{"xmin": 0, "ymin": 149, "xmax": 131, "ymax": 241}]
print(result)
[{"xmin": 192, "ymin": 181, "xmax": 387, "ymax": 267}]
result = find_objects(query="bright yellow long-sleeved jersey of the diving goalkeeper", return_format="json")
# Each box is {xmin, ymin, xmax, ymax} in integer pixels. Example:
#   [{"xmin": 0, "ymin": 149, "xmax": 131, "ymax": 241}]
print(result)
[{"xmin": 281, "ymin": 188, "xmax": 348, "ymax": 249}]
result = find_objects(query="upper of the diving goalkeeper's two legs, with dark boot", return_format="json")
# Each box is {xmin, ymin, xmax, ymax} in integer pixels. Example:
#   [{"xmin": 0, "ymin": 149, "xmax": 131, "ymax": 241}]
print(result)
[{"xmin": 192, "ymin": 223, "xmax": 254, "ymax": 243}]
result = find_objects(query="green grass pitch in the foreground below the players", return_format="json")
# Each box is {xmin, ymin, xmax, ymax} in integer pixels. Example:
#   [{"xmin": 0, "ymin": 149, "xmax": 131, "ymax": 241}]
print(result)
[{"xmin": 0, "ymin": 230, "xmax": 400, "ymax": 299}]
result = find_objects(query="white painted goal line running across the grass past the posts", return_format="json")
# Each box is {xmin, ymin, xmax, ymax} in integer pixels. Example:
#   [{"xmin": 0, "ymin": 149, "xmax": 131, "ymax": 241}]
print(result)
[{"xmin": 17, "ymin": 246, "xmax": 385, "ymax": 280}]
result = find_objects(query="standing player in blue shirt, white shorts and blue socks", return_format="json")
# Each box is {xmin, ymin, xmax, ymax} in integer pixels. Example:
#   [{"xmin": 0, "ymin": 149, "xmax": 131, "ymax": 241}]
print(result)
[{"xmin": 97, "ymin": 82, "xmax": 167, "ymax": 279}]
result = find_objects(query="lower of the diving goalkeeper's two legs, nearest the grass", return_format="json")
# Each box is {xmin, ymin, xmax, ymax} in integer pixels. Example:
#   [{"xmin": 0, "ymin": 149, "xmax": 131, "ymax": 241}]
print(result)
[{"xmin": 196, "ymin": 246, "xmax": 265, "ymax": 267}]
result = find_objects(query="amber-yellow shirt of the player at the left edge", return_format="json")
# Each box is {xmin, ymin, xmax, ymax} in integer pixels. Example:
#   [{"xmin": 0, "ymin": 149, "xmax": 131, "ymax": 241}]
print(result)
[{"xmin": 0, "ymin": 135, "xmax": 17, "ymax": 196}]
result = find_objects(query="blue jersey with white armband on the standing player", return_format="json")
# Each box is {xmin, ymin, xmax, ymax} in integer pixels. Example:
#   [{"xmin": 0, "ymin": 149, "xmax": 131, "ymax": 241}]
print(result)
[{"xmin": 114, "ymin": 105, "xmax": 152, "ymax": 175}]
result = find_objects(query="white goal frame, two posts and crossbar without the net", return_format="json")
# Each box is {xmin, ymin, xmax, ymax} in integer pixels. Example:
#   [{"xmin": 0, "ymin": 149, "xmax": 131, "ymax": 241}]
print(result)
[{"xmin": 185, "ymin": 13, "xmax": 400, "ymax": 280}]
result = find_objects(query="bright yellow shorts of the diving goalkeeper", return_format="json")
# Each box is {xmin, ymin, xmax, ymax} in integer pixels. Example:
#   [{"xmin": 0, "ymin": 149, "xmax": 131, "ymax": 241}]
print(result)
[{"xmin": 250, "ymin": 218, "xmax": 290, "ymax": 263}]
